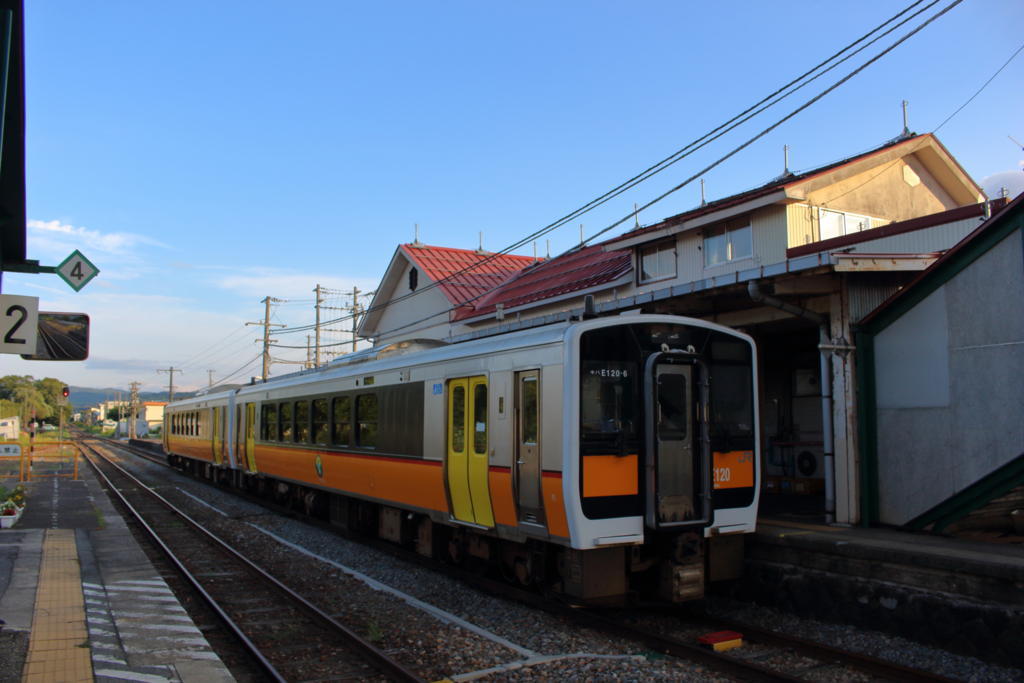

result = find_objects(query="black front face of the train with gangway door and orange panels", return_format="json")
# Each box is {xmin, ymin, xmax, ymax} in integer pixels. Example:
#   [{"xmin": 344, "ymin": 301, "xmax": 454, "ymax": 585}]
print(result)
[{"xmin": 580, "ymin": 323, "xmax": 757, "ymax": 526}]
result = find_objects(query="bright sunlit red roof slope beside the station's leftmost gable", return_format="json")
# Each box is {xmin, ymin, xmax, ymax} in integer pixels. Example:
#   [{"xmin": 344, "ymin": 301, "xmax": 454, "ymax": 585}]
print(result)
[{"xmin": 401, "ymin": 244, "xmax": 538, "ymax": 306}]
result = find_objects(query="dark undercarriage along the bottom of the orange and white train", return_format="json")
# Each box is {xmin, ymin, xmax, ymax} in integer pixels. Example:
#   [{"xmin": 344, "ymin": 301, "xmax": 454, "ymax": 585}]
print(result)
[{"xmin": 168, "ymin": 455, "xmax": 743, "ymax": 605}]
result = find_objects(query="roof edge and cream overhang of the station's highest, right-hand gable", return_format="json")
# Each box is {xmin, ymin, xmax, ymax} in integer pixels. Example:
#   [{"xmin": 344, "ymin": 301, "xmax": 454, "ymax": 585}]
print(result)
[{"xmin": 605, "ymin": 133, "xmax": 984, "ymax": 249}]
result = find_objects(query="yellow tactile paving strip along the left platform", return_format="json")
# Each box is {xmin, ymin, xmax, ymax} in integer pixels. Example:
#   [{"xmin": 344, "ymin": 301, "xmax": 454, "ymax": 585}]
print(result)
[{"xmin": 22, "ymin": 529, "xmax": 92, "ymax": 683}]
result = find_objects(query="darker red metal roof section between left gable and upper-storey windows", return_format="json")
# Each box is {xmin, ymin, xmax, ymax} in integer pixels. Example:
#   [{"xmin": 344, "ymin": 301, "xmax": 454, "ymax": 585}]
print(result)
[{"xmin": 455, "ymin": 244, "xmax": 632, "ymax": 321}]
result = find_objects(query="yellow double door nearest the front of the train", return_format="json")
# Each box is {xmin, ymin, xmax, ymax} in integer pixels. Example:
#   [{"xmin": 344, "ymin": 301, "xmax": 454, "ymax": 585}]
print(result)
[{"xmin": 446, "ymin": 377, "xmax": 495, "ymax": 526}]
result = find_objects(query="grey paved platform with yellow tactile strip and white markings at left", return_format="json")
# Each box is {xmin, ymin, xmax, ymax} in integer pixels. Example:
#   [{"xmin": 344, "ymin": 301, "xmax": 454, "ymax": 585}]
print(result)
[{"xmin": 0, "ymin": 456, "xmax": 233, "ymax": 683}]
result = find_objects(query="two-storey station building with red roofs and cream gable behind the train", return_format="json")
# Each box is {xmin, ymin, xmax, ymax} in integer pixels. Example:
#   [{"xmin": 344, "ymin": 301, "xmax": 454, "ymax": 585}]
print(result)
[{"xmin": 359, "ymin": 134, "xmax": 1024, "ymax": 524}]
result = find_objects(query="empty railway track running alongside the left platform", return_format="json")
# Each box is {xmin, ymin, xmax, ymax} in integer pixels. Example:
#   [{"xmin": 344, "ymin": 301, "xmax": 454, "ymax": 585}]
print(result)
[{"xmin": 82, "ymin": 440, "xmax": 423, "ymax": 681}]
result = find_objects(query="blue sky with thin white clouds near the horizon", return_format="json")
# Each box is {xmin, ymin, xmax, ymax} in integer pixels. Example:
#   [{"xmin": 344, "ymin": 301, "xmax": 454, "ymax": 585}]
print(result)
[{"xmin": 0, "ymin": 0, "xmax": 1024, "ymax": 391}]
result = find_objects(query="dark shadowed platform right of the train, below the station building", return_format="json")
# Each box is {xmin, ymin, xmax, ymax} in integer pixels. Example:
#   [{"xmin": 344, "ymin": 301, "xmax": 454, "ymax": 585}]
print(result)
[{"xmin": 734, "ymin": 516, "xmax": 1024, "ymax": 669}]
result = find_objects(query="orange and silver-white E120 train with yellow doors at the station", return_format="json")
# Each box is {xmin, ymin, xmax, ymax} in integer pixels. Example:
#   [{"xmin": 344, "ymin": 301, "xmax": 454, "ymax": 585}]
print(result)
[{"xmin": 164, "ymin": 314, "xmax": 761, "ymax": 602}]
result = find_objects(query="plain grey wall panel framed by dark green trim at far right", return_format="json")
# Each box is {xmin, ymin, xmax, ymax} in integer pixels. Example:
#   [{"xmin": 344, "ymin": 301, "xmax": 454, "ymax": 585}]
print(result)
[{"xmin": 874, "ymin": 230, "xmax": 1024, "ymax": 524}]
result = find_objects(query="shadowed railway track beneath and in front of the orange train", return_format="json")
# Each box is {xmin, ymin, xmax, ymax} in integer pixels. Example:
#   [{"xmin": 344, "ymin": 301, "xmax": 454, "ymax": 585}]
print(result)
[{"xmin": 90, "ymin": 443, "xmax": 950, "ymax": 682}]
